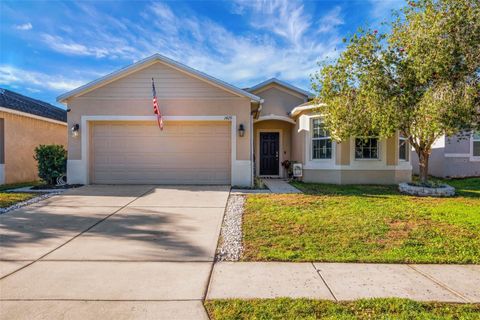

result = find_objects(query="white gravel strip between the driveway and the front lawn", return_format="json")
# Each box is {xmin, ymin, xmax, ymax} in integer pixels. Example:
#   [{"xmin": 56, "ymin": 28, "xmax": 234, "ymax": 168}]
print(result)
[{"xmin": 215, "ymin": 194, "xmax": 245, "ymax": 261}]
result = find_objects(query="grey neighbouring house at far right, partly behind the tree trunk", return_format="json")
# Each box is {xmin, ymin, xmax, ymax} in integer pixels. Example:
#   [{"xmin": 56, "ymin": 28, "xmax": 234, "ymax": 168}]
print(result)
[{"xmin": 411, "ymin": 133, "xmax": 480, "ymax": 178}]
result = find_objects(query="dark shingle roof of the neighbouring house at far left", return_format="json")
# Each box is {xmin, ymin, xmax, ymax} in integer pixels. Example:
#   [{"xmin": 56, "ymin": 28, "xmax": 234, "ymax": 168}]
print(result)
[{"xmin": 0, "ymin": 88, "xmax": 67, "ymax": 122}]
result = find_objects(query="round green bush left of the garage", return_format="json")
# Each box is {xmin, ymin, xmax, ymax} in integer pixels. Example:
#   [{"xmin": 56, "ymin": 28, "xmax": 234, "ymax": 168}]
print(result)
[{"xmin": 34, "ymin": 144, "xmax": 67, "ymax": 185}]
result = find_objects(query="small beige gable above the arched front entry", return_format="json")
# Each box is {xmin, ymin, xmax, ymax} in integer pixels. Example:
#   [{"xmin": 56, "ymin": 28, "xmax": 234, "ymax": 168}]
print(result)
[{"xmin": 252, "ymin": 84, "xmax": 307, "ymax": 116}]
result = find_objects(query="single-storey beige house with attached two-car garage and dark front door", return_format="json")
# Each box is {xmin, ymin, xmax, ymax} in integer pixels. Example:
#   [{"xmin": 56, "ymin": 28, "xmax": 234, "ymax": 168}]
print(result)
[{"xmin": 58, "ymin": 54, "xmax": 411, "ymax": 186}]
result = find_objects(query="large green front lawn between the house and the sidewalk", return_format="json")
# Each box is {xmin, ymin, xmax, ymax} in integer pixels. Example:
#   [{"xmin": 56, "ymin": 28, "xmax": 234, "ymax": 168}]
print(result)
[{"xmin": 242, "ymin": 178, "xmax": 480, "ymax": 264}]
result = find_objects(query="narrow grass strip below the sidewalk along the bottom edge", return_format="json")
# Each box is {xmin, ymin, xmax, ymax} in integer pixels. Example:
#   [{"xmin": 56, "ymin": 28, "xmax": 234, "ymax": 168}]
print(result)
[{"xmin": 205, "ymin": 298, "xmax": 480, "ymax": 320}]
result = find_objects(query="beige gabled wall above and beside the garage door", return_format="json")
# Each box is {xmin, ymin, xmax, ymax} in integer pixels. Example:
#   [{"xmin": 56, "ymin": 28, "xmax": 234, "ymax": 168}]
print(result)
[{"xmin": 68, "ymin": 62, "xmax": 251, "ymax": 160}]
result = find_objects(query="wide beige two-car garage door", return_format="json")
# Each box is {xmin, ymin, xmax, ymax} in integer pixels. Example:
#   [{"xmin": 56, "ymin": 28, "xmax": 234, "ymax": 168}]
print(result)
[{"xmin": 91, "ymin": 122, "xmax": 231, "ymax": 184}]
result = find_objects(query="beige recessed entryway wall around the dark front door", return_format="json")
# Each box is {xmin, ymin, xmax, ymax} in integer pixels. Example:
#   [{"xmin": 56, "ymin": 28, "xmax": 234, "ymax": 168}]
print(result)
[{"xmin": 253, "ymin": 120, "xmax": 293, "ymax": 177}]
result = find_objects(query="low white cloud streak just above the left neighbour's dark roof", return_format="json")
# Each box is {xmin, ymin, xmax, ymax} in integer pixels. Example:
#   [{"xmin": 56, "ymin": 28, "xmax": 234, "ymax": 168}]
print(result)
[{"xmin": 0, "ymin": 65, "xmax": 86, "ymax": 92}]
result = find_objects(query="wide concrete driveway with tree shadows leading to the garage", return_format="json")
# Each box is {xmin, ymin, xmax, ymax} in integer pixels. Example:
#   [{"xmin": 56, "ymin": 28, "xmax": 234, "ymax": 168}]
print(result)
[{"xmin": 0, "ymin": 185, "xmax": 230, "ymax": 319}]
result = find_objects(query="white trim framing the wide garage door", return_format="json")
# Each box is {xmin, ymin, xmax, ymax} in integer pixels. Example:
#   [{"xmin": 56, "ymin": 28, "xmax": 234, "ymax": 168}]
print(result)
[{"xmin": 77, "ymin": 115, "xmax": 251, "ymax": 185}]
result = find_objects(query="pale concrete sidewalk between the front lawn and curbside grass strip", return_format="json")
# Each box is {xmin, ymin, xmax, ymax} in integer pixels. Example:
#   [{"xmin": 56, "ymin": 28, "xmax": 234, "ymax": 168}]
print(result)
[{"xmin": 207, "ymin": 262, "xmax": 480, "ymax": 303}]
